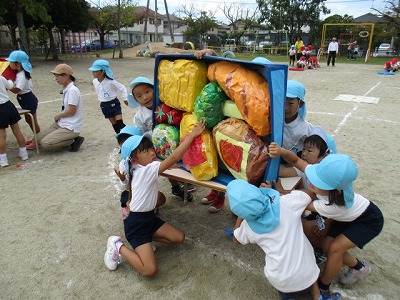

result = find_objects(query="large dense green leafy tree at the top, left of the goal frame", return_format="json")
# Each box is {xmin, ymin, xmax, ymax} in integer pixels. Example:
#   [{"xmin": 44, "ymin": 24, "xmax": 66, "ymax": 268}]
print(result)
[{"xmin": 257, "ymin": 0, "xmax": 330, "ymax": 40}]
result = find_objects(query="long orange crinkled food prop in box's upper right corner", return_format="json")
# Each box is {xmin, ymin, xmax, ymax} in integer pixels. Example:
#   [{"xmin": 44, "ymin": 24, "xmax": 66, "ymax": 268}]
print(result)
[{"xmin": 207, "ymin": 61, "xmax": 271, "ymax": 136}]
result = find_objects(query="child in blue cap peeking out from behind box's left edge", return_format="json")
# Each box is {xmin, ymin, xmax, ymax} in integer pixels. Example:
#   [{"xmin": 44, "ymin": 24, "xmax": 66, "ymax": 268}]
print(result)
[{"xmin": 128, "ymin": 76, "xmax": 195, "ymax": 201}]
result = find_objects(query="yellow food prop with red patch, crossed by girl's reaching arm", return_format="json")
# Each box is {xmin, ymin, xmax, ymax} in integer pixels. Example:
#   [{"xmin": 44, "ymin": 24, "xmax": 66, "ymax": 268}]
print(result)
[{"xmin": 180, "ymin": 114, "xmax": 218, "ymax": 180}]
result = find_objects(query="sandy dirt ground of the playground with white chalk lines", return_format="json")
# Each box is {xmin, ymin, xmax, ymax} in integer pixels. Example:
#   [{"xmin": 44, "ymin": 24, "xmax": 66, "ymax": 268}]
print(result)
[{"xmin": 0, "ymin": 45, "xmax": 400, "ymax": 300}]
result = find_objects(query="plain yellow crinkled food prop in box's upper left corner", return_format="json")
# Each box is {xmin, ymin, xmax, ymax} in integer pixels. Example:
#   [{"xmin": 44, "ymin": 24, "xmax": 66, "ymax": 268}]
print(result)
[{"xmin": 157, "ymin": 59, "xmax": 207, "ymax": 112}]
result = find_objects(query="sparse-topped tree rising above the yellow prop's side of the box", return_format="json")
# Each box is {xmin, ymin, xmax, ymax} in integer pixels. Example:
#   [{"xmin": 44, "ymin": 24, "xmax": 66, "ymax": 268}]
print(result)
[{"xmin": 178, "ymin": 5, "xmax": 218, "ymax": 47}]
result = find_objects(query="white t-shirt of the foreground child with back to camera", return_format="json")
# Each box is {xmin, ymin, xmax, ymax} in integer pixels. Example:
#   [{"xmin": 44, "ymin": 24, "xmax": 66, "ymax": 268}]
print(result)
[{"xmin": 234, "ymin": 191, "xmax": 320, "ymax": 293}]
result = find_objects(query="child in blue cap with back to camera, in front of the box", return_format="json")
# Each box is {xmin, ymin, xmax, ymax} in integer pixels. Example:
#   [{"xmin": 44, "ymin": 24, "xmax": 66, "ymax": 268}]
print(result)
[{"xmin": 226, "ymin": 179, "xmax": 320, "ymax": 300}]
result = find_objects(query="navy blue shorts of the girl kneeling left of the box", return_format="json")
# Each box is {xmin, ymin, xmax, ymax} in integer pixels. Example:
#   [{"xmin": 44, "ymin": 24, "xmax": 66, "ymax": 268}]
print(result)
[{"xmin": 124, "ymin": 211, "xmax": 165, "ymax": 249}]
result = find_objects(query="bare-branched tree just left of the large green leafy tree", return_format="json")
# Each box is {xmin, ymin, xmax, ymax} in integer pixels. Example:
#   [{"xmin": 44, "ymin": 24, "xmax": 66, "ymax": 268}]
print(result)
[{"xmin": 221, "ymin": 3, "xmax": 258, "ymax": 45}]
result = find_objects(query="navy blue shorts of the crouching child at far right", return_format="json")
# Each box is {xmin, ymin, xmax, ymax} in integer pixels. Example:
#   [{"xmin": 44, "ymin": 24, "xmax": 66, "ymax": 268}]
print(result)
[{"xmin": 327, "ymin": 202, "xmax": 384, "ymax": 249}]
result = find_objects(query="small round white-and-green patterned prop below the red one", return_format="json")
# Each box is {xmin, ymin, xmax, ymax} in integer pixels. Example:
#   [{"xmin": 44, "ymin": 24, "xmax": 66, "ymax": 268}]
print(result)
[{"xmin": 152, "ymin": 124, "xmax": 179, "ymax": 159}]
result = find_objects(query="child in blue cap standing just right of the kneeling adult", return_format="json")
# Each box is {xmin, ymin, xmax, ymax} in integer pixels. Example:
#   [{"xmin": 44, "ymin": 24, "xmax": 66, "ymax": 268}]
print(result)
[{"xmin": 89, "ymin": 59, "xmax": 128, "ymax": 133}]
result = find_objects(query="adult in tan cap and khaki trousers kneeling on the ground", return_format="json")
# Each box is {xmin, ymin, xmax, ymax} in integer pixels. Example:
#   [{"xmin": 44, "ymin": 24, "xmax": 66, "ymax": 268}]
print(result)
[{"xmin": 38, "ymin": 64, "xmax": 84, "ymax": 152}]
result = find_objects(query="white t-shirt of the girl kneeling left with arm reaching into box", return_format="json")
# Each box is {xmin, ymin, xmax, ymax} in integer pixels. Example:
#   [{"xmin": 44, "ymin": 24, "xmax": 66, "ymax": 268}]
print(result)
[{"xmin": 130, "ymin": 161, "xmax": 161, "ymax": 212}]
